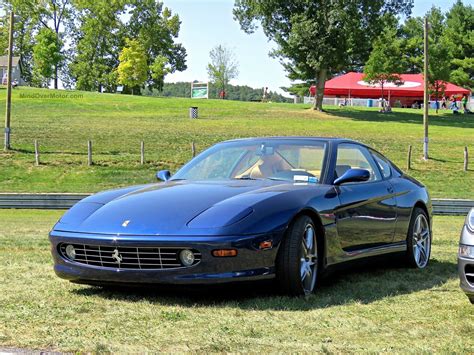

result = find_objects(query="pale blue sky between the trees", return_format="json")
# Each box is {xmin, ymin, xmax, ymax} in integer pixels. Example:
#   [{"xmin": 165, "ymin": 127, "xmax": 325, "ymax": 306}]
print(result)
[{"xmin": 163, "ymin": 0, "xmax": 462, "ymax": 93}]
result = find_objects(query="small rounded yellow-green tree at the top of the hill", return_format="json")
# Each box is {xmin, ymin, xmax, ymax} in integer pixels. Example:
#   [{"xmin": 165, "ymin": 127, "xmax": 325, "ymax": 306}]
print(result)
[{"xmin": 117, "ymin": 40, "xmax": 148, "ymax": 95}]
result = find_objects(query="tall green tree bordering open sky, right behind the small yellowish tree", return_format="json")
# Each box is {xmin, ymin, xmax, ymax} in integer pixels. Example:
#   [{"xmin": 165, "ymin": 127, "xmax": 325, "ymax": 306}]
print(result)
[{"xmin": 126, "ymin": 0, "xmax": 187, "ymax": 90}]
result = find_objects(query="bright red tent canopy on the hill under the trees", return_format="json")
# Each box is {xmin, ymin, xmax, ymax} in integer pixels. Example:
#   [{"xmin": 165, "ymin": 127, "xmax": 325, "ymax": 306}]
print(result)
[{"xmin": 324, "ymin": 72, "xmax": 471, "ymax": 98}]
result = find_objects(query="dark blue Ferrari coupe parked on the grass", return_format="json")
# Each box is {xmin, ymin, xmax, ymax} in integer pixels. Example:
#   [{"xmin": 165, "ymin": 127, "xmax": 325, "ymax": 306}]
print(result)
[{"xmin": 50, "ymin": 137, "xmax": 432, "ymax": 295}]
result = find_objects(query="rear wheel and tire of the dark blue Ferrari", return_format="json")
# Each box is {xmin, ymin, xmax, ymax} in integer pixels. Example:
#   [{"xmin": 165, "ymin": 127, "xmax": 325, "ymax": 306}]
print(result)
[{"xmin": 406, "ymin": 207, "xmax": 432, "ymax": 269}]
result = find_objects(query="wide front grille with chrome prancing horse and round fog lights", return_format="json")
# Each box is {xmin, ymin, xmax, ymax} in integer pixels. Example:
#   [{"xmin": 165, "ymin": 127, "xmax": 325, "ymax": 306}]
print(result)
[{"xmin": 58, "ymin": 243, "xmax": 201, "ymax": 270}]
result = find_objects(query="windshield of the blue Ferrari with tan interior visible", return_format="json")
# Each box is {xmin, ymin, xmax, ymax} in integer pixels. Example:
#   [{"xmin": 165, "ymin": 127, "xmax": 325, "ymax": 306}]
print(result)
[{"xmin": 173, "ymin": 140, "xmax": 326, "ymax": 183}]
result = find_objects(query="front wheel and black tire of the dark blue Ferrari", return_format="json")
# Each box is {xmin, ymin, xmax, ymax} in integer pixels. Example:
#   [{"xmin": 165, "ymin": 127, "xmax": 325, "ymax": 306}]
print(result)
[{"xmin": 276, "ymin": 216, "xmax": 319, "ymax": 296}]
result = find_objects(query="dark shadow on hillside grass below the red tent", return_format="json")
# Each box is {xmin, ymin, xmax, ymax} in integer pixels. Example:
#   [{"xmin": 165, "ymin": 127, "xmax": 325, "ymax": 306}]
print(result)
[{"xmin": 326, "ymin": 108, "xmax": 474, "ymax": 128}]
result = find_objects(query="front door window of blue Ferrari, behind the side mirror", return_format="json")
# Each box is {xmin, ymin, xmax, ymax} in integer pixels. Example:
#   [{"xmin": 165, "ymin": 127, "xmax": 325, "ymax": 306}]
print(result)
[{"xmin": 335, "ymin": 143, "xmax": 382, "ymax": 181}]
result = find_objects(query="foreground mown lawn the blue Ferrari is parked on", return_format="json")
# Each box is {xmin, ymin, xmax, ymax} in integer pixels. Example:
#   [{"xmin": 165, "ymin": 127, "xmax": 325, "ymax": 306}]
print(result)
[{"xmin": 0, "ymin": 210, "xmax": 474, "ymax": 353}]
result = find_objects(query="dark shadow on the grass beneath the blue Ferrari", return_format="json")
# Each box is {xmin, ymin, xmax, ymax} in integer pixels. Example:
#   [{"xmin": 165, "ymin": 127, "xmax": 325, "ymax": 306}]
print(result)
[{"xmin": 72, "ymin": 257, "xmax": 457, "ymax": 311}]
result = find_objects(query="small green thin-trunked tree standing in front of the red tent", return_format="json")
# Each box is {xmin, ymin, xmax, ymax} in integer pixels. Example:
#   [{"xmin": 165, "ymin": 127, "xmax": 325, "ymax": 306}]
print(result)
[{"xmin": 364, "ymin": 27, "xmax": 403, "ymax": 111}]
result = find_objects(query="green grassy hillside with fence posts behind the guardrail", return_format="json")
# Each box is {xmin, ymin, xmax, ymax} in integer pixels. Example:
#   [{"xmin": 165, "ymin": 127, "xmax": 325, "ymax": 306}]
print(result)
[{"xmin": 0, "ymin": 88, "xmax": 474, "ymax": 198}]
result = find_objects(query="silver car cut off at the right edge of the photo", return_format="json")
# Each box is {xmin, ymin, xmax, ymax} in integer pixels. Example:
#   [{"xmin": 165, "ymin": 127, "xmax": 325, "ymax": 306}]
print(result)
[{"xmin": 458, "ymin": 208, "xmax": 474, "ymax": 304}]
